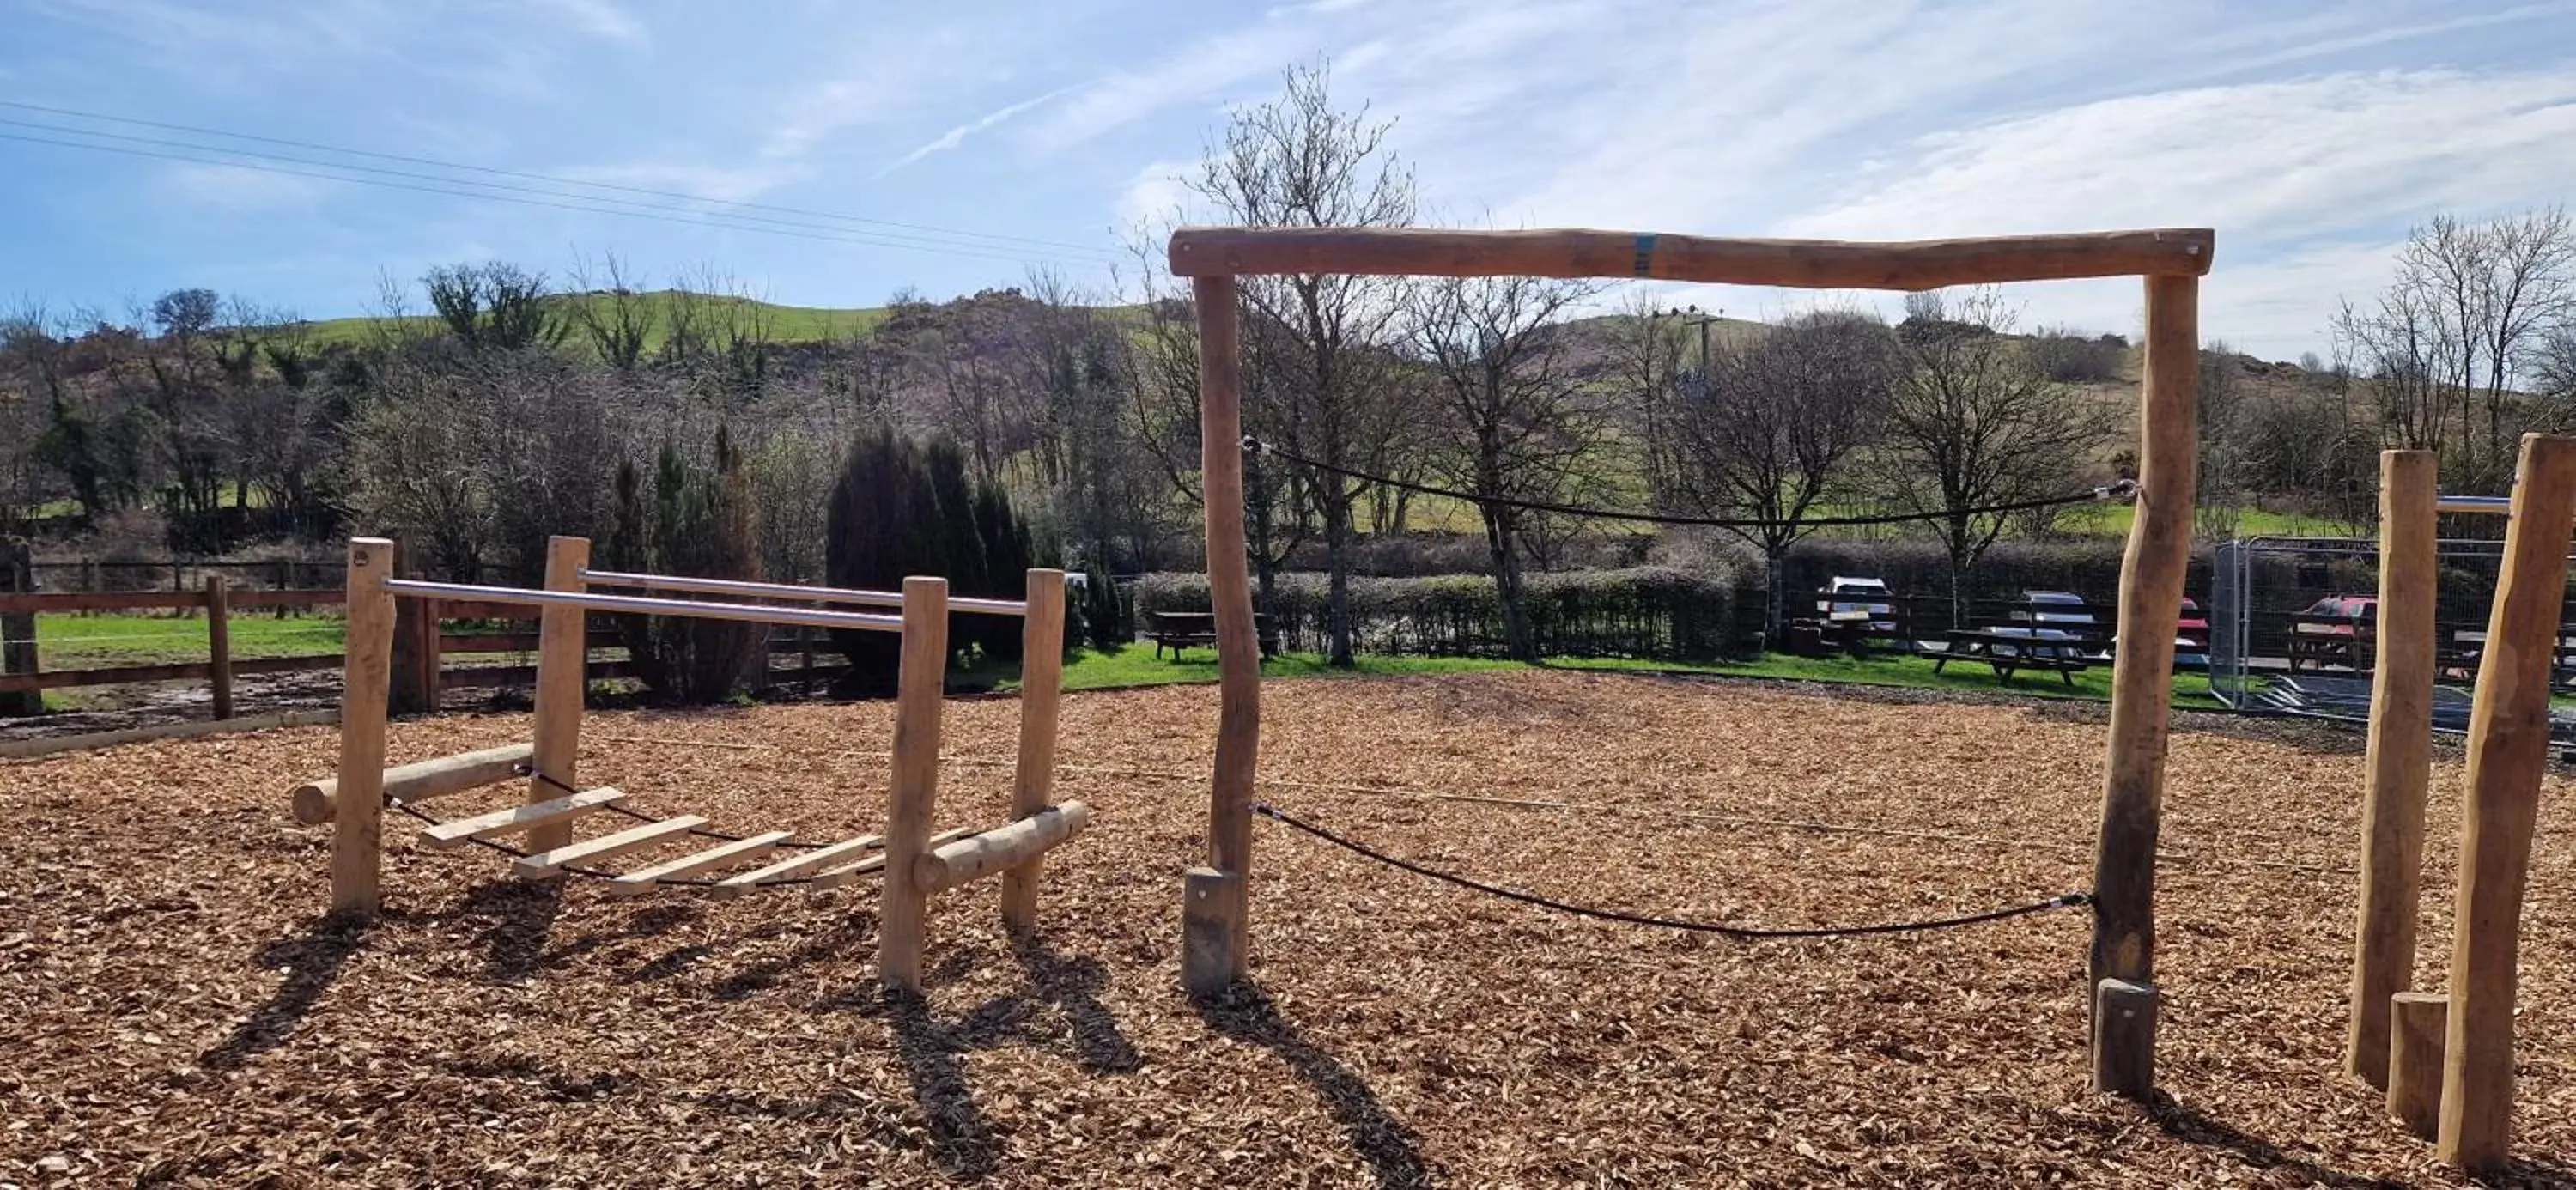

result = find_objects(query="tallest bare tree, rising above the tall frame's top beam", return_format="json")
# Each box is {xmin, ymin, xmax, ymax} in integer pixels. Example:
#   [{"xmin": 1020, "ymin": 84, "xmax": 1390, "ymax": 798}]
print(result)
[{"xmin": 1190, "ymin": 64, "xmax": 1414, "ymax": 667}]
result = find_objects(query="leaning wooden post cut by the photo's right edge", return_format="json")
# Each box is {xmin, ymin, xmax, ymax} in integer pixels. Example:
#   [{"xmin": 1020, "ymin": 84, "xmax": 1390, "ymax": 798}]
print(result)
[{"xmin": 2437, "ymin": 433, "xmax": 2576, "ymax": 1175}]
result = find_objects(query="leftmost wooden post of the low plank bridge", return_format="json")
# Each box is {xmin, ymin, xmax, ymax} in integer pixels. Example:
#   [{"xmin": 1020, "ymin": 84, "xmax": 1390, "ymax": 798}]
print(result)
[{"xmin": 330, "ymin": 538, "xmax": 394, "ymax": 917}]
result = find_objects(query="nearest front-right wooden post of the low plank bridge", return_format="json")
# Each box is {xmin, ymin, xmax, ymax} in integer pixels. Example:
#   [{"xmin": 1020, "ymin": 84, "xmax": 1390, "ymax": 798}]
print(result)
[{"xmin": 876, "ymin": 577, "xmax": 948, "ymax": 992}]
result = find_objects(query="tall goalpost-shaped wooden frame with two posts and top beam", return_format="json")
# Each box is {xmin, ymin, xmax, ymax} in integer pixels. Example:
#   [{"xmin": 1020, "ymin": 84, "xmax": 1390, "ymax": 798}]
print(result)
[{"xmin": 1170, "ymin": 227, "xmax": 2218, "ymax": 1097}]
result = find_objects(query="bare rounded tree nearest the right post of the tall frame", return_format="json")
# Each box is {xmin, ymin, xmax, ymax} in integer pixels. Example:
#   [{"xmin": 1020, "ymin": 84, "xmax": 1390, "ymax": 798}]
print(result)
[{"xmin": 1873, "ymin": 288, "xmax": 2110, "ymax": 626}]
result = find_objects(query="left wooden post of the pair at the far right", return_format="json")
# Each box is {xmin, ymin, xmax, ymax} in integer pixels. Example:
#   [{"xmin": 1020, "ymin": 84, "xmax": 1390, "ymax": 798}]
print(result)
[{"xmin": 2344, "ymin": 451, "xmax": 2442, "ymax": 1090}]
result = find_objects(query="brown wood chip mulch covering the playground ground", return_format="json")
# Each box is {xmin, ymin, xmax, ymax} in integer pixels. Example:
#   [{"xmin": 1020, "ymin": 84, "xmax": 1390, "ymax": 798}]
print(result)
[{"xmin": 0, "ymin": 672, "xmax": 2576, "ymax": 1187}]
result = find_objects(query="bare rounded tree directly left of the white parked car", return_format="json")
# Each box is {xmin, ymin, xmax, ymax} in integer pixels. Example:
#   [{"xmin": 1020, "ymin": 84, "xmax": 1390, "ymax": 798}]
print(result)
[{"xmin": 1680, "ymin": 309, "xmax": 1899, "ymax": 641}]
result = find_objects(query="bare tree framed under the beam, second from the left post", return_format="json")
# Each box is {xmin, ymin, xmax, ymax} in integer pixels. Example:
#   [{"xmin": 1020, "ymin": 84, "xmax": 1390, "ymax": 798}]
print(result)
[{"xmin": 1406, "ymin": 276, "xmax": 1605, "ymax": 662}]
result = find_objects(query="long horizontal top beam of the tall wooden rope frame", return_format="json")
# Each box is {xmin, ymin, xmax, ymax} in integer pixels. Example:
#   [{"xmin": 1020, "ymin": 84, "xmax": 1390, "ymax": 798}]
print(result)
[{"xmin": 1170, "ymin": 227, "xmax": 2218, "ymax": 288}]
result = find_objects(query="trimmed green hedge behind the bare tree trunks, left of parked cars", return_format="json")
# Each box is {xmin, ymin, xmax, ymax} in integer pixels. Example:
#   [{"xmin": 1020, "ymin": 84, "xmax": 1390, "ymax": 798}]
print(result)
[{"xmin": 1136, "ymin": 567, "xmax": 1739, "ymax": 659}]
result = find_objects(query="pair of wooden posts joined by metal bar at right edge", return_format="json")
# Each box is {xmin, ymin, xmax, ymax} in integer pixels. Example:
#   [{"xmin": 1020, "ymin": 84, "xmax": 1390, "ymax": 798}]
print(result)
[{"xmin": 2344, "ymin": 433, "xmax": 2576, "ymax": 1175}]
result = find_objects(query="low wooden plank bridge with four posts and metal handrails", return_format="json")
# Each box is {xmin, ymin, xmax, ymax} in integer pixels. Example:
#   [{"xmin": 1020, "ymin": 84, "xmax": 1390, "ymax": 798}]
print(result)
[{"xmin": 291, "ymin": 536, "xmax": 1090, "ymax": 992}]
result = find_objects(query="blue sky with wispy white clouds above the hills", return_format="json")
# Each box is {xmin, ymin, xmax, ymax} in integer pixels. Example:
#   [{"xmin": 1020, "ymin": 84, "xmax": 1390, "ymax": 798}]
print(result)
[{"xmin": 0, "ymin": 0, "xmax": 2576, "ymax": 358}]
